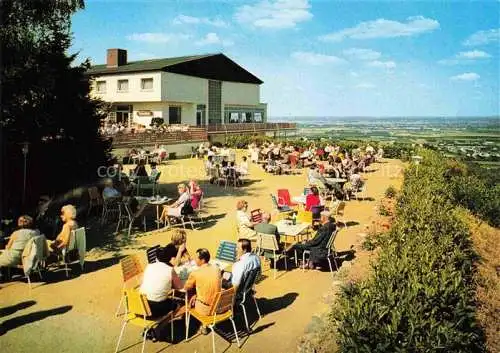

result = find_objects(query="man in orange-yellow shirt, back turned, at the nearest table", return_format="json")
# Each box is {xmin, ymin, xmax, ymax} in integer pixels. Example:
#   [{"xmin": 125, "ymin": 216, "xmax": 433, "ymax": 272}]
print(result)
[{"xmin": 184, "ymin": 249, "xmax": 221, "ymax": 315}]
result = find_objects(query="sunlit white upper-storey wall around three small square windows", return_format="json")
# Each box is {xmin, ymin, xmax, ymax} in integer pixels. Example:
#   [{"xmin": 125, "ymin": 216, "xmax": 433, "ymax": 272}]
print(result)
[{"xmin": 91, "ymin": 72, "xmax": 162, "ymax": 103}]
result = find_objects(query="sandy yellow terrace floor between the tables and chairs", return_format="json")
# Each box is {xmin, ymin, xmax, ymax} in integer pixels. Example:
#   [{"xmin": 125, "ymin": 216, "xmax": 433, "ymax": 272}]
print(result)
[{"xmin": 0, "ymin": 153, "xmax": 401, "ymax": 353}]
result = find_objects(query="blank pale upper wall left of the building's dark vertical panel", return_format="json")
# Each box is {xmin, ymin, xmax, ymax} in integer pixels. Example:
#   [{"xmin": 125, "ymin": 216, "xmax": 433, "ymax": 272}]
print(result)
[{"xmin": 161, "ymin": 72, "xmax": 208, "ymax": 104}]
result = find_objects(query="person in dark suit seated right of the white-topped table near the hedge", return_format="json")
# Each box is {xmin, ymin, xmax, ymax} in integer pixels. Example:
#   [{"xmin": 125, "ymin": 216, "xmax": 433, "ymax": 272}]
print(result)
[{"xmin": 293, "ymin": 211, "xmax": 336, "ymax": 269}]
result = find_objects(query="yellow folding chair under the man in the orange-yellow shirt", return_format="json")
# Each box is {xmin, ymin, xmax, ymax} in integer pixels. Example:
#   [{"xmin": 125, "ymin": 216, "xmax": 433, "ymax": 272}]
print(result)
[{"xmin": 186, "ymin": 287, "xmax": 240, "ymax": 353}]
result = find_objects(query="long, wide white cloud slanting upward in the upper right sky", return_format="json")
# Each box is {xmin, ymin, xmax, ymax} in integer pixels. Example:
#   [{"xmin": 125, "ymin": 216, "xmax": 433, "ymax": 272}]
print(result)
[{"xmin": 319, "ymin": 16, "xmax": 439, "ymax": 42}]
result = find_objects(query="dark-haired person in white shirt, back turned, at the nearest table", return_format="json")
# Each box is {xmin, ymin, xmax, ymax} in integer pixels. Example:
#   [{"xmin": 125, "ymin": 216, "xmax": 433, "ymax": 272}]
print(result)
[{"xmin": 139, "ymin": 248, "xmax": 183, "ymax": 317}]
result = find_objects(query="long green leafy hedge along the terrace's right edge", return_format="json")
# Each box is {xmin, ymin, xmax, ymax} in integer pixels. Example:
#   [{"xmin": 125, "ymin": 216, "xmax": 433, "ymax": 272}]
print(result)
[{"xmin": 330, "ymin": 151, "xmax": 485, "ymax": 352}]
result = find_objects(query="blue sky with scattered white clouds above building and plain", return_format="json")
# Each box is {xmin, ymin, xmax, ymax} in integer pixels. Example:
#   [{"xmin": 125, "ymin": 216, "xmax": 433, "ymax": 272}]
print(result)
[{"xmin": 70, "ymin": 0, "xmax": 500, "ymax": 117}]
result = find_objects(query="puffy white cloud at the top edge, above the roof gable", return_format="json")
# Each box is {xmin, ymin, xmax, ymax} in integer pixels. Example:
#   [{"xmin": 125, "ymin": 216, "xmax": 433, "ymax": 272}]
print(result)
[{"xmin": 234, "ymin": 0, "xmax": 313, "ymax": 29}]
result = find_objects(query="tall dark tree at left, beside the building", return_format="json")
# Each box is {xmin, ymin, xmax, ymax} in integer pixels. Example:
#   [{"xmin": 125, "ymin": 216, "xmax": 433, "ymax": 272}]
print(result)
[{"xmin": 0, "ymin": 0, "xmax": 110, "ymax": 215}]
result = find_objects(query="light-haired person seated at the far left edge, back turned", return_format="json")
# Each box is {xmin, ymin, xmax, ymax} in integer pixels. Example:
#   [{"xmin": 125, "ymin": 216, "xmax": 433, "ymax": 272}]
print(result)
[{"xmin": 0, "ymin": 216, "xmax": 40, "ymax": 267}]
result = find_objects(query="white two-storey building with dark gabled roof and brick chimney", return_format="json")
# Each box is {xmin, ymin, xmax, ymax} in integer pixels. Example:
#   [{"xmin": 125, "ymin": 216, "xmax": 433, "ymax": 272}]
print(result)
[{"xmin": 87, "ymin": 49, "xmax": 267, "ymax": 126}]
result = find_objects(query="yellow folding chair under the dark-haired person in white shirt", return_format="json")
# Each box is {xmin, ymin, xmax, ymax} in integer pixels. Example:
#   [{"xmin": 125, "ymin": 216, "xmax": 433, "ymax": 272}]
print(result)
[{"xmin": 115, "ymin": 289, "xmax": 186, "ymax": 353}]
